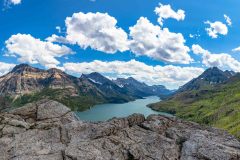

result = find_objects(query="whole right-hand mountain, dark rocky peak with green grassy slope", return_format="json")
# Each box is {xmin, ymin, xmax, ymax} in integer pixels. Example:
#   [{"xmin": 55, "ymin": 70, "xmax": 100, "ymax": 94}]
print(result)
[{"xmin": 149, "ymin": 68, "xmax": 240, "ymax": 138}]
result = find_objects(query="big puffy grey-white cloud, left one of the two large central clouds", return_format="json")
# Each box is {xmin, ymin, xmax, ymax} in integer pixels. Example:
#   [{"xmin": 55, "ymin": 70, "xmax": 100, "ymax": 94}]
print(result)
[{"xmin": 65, "ymin": 12, "xmax": 128, "ymax": 54}]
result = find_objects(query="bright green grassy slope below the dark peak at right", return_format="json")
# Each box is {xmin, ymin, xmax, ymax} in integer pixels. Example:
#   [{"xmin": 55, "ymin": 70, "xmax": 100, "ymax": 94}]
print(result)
[{"xmin": 150, "ymin": 82, "xmax": 240, "ymax": 138}]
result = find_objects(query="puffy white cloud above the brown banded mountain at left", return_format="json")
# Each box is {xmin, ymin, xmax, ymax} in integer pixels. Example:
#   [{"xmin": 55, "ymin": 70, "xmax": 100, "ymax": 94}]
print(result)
[{"xmin": 5, "ymin": 34, "xmax": 73, "ymax": 68}]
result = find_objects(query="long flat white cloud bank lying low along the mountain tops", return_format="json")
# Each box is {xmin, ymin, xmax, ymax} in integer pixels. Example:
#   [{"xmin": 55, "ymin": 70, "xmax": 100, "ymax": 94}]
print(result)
[{"xmin": 63, "ymin": 60, "xmax": 203, "ymax": 88}]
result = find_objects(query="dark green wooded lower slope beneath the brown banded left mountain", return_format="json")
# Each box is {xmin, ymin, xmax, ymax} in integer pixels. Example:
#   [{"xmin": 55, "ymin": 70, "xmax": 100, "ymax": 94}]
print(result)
[{"xmin": 0, "ymin": 88, "xmax": 105, "ymax": 111}]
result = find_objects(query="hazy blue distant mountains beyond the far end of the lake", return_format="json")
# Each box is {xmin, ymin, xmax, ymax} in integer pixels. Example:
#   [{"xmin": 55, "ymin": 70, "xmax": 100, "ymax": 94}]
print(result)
[{"xmin": 114, "ymin": 77, "xmax": 172, "ymax": 97}]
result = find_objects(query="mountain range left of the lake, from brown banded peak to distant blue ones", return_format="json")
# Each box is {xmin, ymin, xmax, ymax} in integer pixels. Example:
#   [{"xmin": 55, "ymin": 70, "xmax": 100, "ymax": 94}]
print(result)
[{"xmin": 0, "ymin": 64, "xmax": 171, "ymax": 111}]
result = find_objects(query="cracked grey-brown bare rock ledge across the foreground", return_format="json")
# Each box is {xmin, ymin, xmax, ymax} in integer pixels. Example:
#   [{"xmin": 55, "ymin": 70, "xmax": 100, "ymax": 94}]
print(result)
[{"xmin": 0, "ymin": 100, "xmax": 240, "ymax": 160}]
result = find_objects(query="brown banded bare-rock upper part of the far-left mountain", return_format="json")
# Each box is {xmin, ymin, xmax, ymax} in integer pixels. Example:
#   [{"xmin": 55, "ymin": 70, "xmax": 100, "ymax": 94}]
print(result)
[{"xmin": 0, "ymin": 64, "xmax": 78, "ymax": 96}]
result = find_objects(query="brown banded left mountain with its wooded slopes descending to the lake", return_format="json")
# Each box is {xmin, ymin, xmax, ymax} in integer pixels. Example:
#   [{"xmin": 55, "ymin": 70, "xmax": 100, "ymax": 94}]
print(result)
[{"xmin": 0, "ymin": 64, "xmax": 134, "ymax": 110}]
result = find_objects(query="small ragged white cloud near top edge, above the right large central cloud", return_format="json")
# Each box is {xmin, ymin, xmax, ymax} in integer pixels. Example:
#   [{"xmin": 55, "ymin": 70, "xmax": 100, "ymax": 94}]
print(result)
[{"xmin": 155, "ymin": 3, "xmax": 185, "ymax": 26}]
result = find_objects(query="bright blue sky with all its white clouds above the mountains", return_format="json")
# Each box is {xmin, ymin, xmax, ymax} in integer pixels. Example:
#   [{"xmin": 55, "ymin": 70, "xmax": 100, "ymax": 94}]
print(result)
[{"xmin": 0, "ymin": 0, "xmax": 240, "ymax": 89}]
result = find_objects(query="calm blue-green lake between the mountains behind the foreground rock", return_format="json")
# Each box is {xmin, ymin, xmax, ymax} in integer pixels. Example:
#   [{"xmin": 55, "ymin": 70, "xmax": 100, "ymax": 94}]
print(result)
[{"xmin": 76, "ymin": 96, "xmax": 172, "ymax": 122}]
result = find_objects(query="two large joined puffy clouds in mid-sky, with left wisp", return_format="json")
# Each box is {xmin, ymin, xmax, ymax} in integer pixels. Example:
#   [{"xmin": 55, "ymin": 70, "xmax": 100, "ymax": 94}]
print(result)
[{"xmin": 49, "ymin": 12, "xmax": 193, "ymax": 64}]
